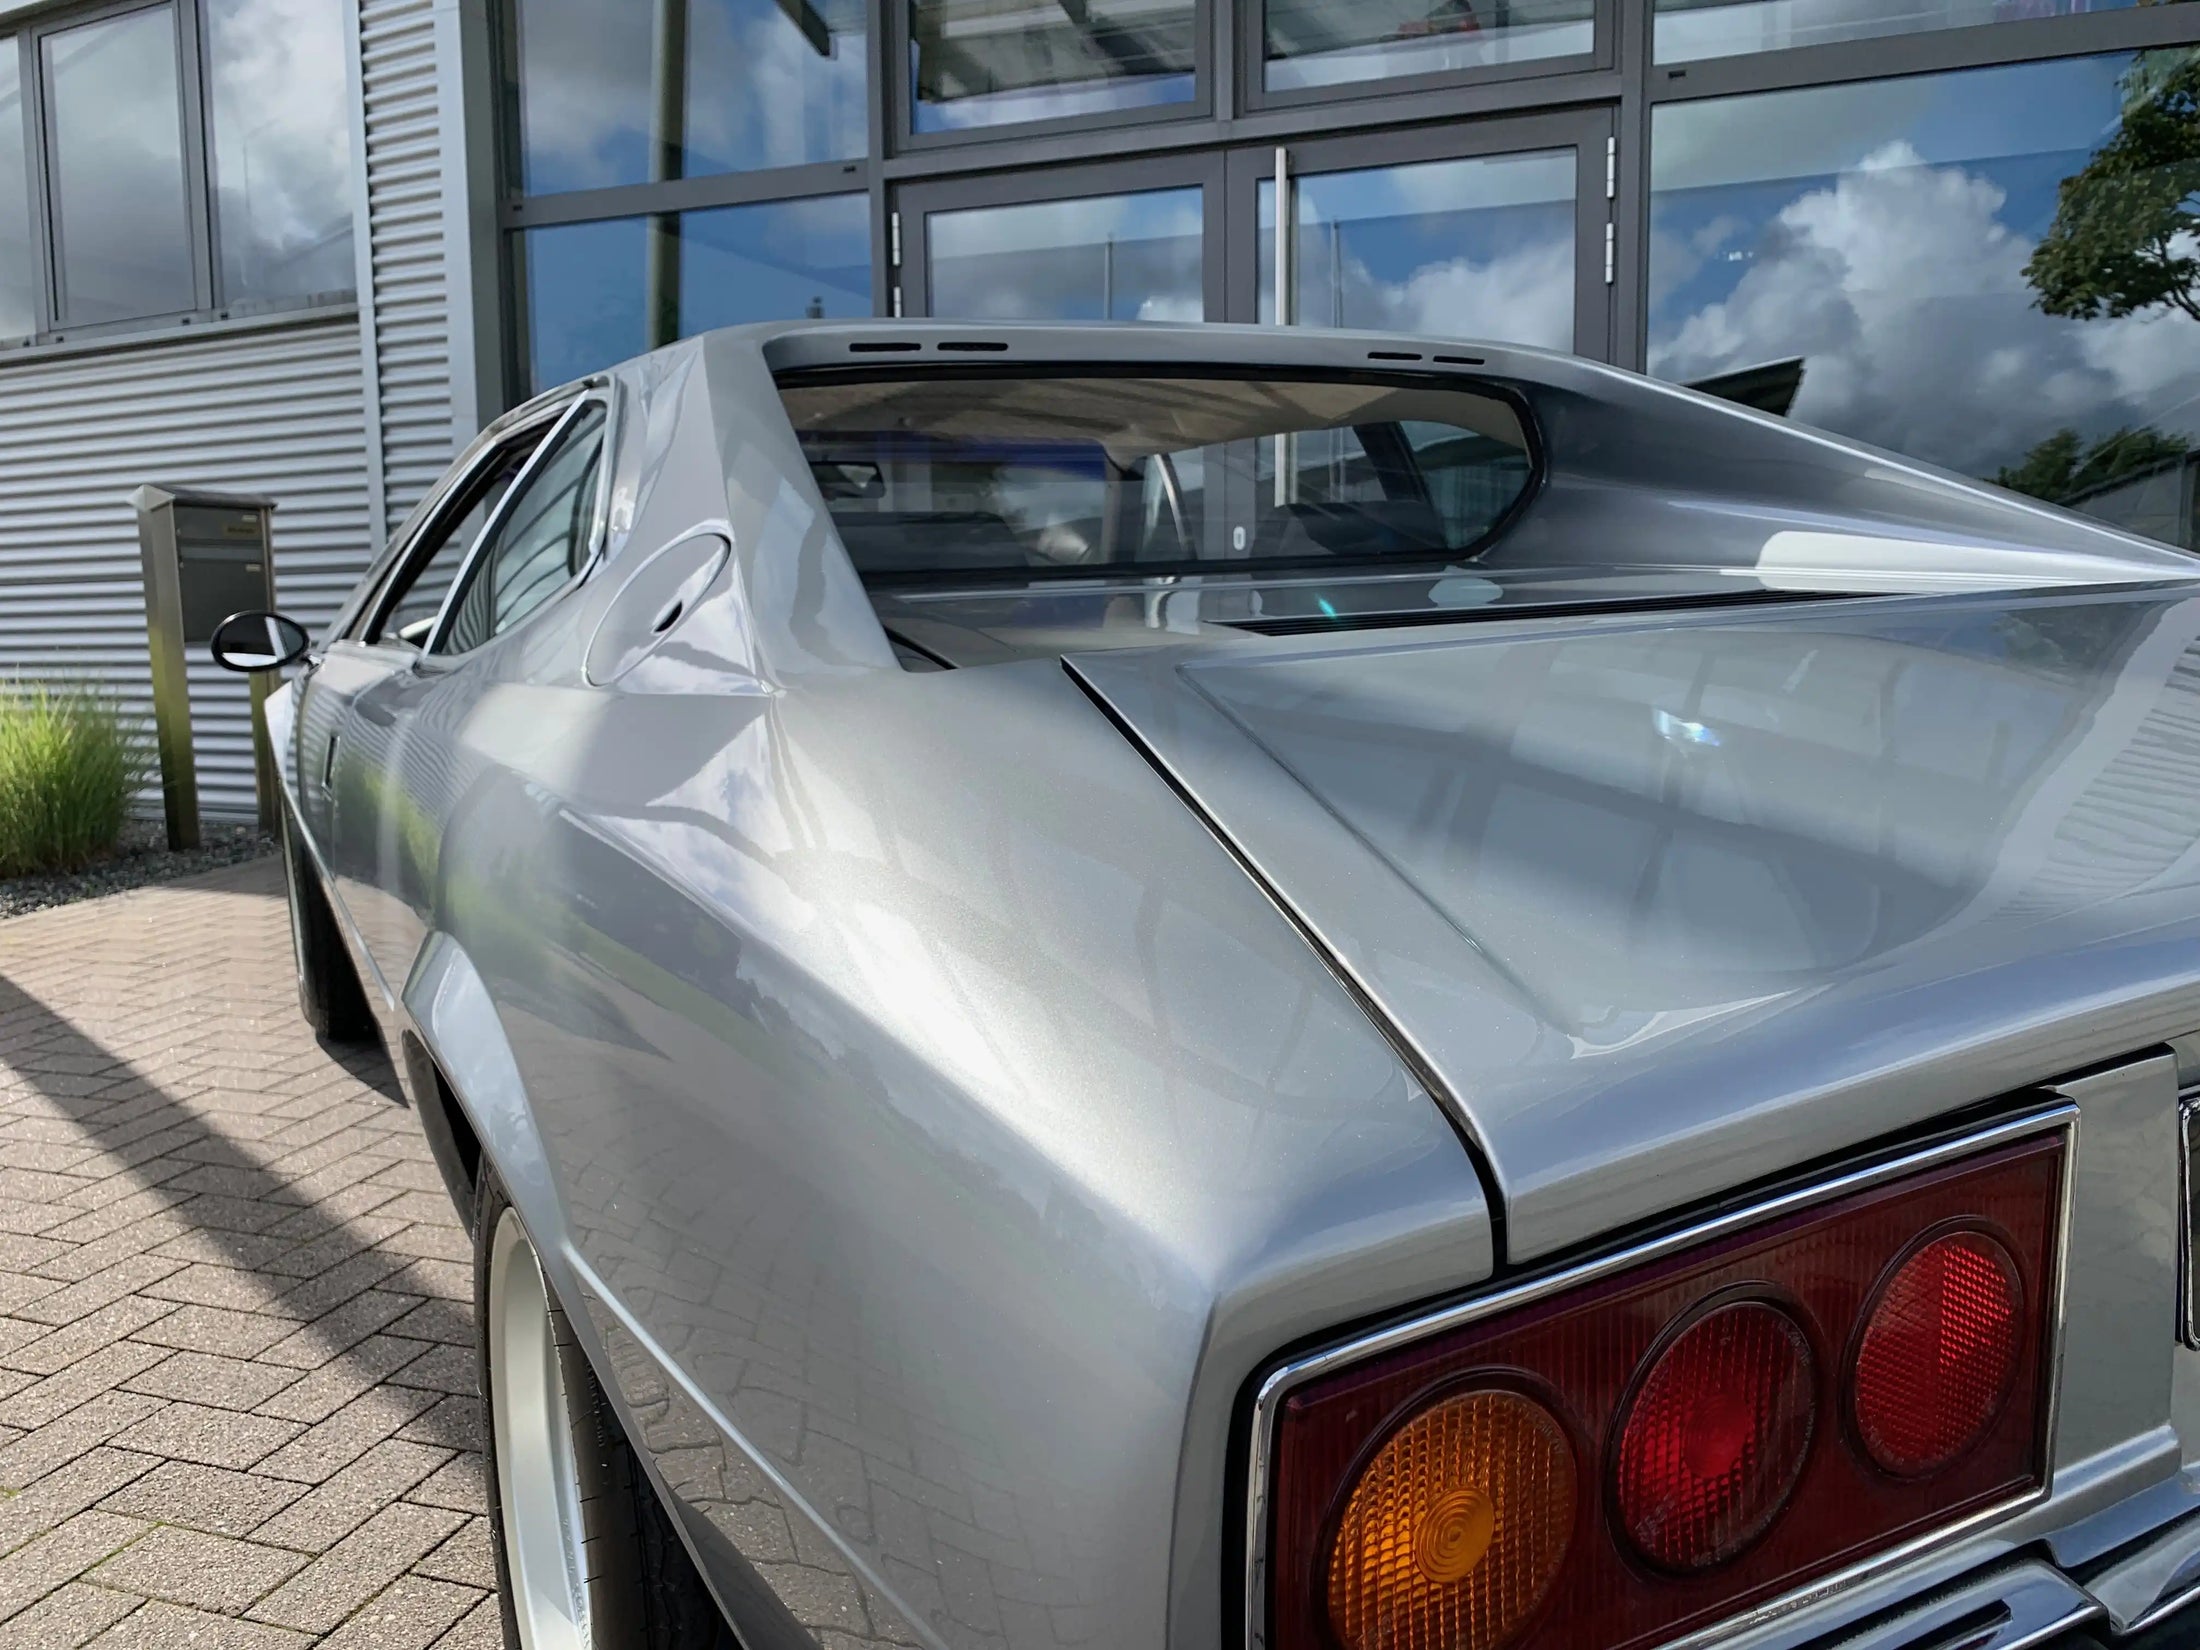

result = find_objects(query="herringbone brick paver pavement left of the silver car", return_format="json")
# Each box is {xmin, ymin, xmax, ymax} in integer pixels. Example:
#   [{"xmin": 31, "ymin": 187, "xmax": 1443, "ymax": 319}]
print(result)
[{"xmin": 0, "ymin": 860, "xmax": 499, "ymax": 1650}]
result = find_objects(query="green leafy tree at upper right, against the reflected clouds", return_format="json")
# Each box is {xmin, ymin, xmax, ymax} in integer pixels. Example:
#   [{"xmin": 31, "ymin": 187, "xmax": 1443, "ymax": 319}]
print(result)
[{"xmin": 2024, "ymin": 48, "xmax": 2200, "ymax": 321}]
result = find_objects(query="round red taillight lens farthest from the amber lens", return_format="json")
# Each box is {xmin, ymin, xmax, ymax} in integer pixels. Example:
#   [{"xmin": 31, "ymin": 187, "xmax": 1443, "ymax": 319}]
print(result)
[{"xmin": 1852, "ymin": 1232, "xmax": 2024, "ymax": 1478}]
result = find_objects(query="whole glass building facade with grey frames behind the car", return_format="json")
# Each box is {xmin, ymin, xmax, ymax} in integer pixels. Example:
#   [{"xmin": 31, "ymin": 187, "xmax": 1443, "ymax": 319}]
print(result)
[{"xmin": 499, "ymin": 0, "xmax": 2200, "ymax": 546}]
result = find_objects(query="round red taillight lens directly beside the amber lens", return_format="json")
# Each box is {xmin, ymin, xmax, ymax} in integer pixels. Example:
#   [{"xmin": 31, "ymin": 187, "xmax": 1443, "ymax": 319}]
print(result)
[{"xmin": 1613, "ymin": 1300, "xmax": 1817, "ymax": 1571}]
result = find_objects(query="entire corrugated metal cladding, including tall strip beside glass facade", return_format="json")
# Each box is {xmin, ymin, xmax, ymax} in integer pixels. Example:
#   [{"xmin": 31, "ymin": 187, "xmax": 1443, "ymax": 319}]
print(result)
[{"xmin": 0, "ymin": 0, "xmax": 464, "ymax": 818}]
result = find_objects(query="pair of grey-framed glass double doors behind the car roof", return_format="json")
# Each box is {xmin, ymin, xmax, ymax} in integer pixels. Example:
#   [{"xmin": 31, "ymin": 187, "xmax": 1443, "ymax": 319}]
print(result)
[{"xmin": 895, "ymin": 110, "xmax": 1613, "ymax": 359}]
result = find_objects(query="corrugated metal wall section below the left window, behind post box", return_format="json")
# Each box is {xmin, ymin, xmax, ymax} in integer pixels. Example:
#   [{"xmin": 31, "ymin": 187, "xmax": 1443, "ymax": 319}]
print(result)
[{"xmin": 0, "ymin": 310, "xmax": 383, "ymax": 818}]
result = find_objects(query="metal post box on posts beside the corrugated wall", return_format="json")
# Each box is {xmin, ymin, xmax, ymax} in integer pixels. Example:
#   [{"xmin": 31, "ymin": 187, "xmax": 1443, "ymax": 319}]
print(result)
[{"xmin": 130, "ymin": 486, "xmax": 275, "ymax": 847}]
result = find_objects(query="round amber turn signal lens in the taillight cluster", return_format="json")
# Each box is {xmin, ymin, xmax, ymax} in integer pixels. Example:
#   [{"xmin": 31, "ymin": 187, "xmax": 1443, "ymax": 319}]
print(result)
[{"xmin": 1329, "ymin": 1388, "xmax": 1575, "ymax": 1650}]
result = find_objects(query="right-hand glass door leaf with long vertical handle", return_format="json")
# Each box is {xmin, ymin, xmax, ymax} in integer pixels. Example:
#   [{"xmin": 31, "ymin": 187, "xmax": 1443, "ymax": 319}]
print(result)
[{"xmin": 1228, "ymin": 110, "xmax": 1613, "ymax": 359}]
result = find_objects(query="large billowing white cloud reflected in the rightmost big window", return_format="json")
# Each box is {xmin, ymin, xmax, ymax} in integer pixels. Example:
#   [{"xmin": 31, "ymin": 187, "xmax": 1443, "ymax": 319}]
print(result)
[{"xmin": 1650, "ymin": 141, "xmax": 2200, "ymax": 475}]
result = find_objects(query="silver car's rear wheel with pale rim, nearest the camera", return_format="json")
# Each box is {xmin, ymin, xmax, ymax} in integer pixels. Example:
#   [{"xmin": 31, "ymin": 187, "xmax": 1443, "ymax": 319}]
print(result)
[{"xmin": 473, "ymin": 1166, "xmax": 739, "ymax": 1650}]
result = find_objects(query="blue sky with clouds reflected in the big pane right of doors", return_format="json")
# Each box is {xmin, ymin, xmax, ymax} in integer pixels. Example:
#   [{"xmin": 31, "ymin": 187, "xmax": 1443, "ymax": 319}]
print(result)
[{"xmin": 1650, "ymin": 57, "xmax": 2200, "ymax": 477}]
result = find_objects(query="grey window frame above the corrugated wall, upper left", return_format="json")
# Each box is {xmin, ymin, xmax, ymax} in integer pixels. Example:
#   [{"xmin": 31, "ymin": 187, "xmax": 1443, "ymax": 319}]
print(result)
[{"xmin": 0, "ymin": 0, "xmax": 361, "ymax": 361}]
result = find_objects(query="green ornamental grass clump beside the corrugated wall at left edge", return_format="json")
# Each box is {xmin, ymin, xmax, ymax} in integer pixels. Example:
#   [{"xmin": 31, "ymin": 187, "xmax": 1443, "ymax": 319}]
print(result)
[{"xmin": 0, "ymin": 682, "xmax": 145, "ymax": 878}]
